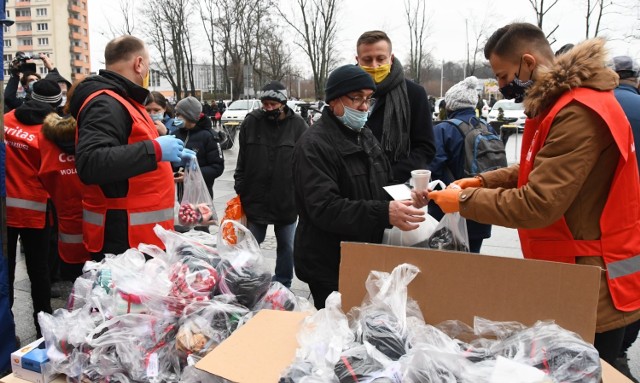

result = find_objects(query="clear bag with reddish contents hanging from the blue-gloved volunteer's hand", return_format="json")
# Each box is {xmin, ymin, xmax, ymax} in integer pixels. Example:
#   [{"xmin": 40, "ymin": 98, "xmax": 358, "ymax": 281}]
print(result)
[{"xmin": 178, "ymin": 158, "xmax": 218, "ymax": 228}]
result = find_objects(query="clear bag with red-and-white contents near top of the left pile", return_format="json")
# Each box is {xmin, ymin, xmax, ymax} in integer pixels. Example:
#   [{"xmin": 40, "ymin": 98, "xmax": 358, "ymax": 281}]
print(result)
[{"xmin": 168, "ymin": 256, "xmax": 219, "ymax": 315}]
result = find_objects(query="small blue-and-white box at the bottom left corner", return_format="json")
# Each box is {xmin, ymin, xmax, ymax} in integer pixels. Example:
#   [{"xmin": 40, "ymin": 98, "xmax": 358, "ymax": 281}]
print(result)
[{"xmin": 11, "ymin": 338, "xmax": 58, "ymax": 383}]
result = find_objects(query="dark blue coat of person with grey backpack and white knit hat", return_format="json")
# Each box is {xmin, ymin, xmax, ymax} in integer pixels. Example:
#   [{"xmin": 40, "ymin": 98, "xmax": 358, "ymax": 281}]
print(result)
[{"xmin": 428, "ymin": 108, "xmax": 495, "ymax": 239}]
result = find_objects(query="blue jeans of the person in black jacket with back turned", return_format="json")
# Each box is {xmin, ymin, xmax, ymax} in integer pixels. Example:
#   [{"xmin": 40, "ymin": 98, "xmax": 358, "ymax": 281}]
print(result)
[{"xmin": 247, "ymin": 222, "xmax": 296, "ymax": 287}]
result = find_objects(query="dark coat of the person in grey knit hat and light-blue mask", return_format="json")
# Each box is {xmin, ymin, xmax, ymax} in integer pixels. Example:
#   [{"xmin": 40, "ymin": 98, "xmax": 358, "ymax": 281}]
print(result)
[{"xmin": 173, "ymin": 115, "xmax": 224, "ymax": 197}]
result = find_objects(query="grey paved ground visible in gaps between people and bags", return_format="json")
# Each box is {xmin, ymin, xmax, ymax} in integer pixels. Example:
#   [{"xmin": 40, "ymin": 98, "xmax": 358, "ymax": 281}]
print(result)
[{"xmin": 10, "ymin": 135, "xmax": 640, "ymax": 378}]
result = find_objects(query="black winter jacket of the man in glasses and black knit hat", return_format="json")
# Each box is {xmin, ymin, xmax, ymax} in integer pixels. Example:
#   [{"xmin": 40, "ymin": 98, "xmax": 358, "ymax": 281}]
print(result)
[{"xmin": 293, "ymin": 108, "xmax": 391, "ymax": 284}]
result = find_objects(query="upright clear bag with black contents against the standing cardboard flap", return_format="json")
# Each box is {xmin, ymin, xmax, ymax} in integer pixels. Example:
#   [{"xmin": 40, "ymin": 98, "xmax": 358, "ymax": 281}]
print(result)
[{"xmin": 350, "ymin": 263, "xmax": 424, "ymax": 360}]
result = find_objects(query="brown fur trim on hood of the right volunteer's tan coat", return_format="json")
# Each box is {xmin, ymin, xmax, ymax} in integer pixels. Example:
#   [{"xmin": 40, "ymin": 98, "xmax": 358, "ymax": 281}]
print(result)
[{"xmin": 524, "ymin": 38, "xmax": 619, "ymax": 117}]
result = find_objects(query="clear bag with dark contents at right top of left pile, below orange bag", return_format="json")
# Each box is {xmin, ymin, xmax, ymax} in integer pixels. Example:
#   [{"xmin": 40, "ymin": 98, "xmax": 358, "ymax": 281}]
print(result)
[{"xmin": 217, "ymin": 221, "xmax": 272, "ymax": 308}]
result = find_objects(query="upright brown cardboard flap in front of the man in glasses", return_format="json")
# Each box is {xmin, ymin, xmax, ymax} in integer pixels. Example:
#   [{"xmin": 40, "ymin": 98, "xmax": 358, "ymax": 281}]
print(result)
[{"xmin": 340, "ymin": 242, "xmax": 600, "ymax": 343}]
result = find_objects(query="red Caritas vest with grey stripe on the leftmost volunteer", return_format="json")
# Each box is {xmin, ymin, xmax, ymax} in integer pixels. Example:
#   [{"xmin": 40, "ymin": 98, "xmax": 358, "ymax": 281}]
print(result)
[{"xmin": 4, "ymin": 110, "xmax": 49, "ymax": 229}]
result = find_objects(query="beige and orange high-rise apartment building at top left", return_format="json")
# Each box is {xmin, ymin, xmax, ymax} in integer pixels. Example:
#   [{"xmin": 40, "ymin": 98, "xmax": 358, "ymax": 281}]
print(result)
[{"xmin": 4, "ymin": 0, "xmax": 91, "ymax": 82}]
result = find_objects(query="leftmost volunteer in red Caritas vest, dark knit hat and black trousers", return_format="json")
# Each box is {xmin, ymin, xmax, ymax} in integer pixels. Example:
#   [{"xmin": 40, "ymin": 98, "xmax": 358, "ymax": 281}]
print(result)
[{"xmin": 4, "ymin": 80, "xmax": 62, "ymax": 337}]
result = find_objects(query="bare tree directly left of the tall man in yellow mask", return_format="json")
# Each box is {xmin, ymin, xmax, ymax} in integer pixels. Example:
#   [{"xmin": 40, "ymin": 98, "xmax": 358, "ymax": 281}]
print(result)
[{"xmin": 278, "ymin": 0, "xmax": 339, "ymax": 98}]
